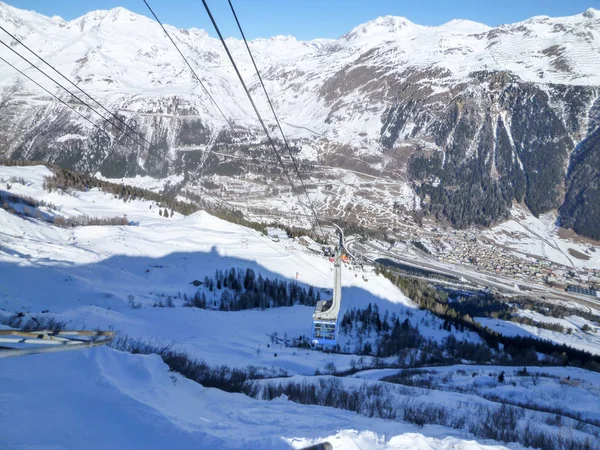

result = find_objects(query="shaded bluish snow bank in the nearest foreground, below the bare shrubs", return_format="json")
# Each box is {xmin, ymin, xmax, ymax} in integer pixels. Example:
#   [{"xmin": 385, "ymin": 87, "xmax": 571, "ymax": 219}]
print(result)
[{"xmin": 0, "ymin": 348, "xmax": 521, "ymax": 450}]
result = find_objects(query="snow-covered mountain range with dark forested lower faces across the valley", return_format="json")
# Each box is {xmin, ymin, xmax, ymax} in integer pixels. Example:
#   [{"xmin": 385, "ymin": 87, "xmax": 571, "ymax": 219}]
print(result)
[{"xmin": 0, "ymin": 3, "xmax": 600, "ymax": 238}]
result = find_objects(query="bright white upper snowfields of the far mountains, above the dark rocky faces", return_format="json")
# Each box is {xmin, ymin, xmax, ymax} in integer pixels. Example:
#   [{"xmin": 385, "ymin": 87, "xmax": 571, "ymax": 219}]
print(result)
[{"xmin": 0, "ymin": 2, "xmax": 600, "ymax": 160}]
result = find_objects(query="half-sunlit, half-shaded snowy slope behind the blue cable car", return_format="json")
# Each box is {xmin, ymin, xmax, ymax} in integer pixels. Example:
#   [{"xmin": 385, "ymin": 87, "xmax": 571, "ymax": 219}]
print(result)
[{"xmin": 0, "ymin": 166, "xmax": 479, "ymax": 374}]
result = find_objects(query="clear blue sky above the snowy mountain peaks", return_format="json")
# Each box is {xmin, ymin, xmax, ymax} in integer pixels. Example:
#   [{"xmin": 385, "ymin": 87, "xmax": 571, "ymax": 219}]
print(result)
[{"xmin": 8, "ymin": 0, "xmax": 600, "ymax": 39}]
